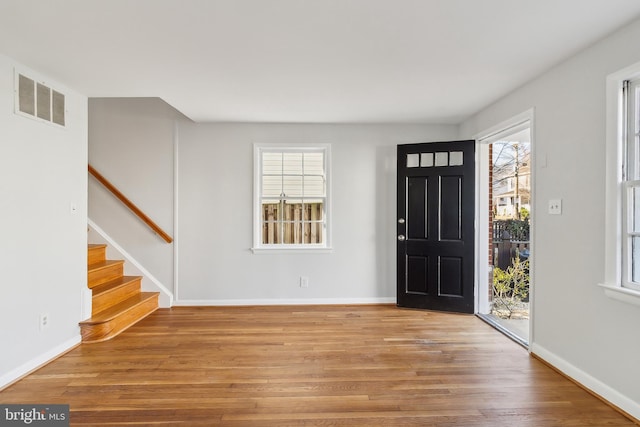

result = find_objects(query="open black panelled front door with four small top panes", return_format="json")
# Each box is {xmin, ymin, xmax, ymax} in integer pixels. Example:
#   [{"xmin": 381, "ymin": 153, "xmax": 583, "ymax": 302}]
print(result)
[{"xmin": 397, "ymin": 141, "xmax": 475, "ymax": 313}]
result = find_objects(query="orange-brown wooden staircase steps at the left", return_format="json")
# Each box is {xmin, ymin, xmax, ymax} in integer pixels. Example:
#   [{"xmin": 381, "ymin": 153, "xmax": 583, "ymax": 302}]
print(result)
[{"xmin": 80, "ymin": 245, "xmax": 160, "ymax": 343}]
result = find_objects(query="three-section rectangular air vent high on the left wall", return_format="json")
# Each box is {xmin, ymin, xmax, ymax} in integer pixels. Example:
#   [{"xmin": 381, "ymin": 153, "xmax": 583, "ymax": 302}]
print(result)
[{"xmin": 15, "ymin": 73, "xmax": 65, "ymax": 126}]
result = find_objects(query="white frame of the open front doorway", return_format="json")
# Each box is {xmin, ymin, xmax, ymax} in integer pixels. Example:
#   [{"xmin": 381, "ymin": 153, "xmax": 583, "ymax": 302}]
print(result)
[{"xmin": 473, "ymin": 108, "xmax": 546, "ymax": 352}]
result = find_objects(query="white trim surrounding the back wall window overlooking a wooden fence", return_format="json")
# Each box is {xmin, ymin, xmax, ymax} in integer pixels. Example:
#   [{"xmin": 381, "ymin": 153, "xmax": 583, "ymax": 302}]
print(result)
[{"xmin": 251, "ymin": 143, "xmax": 333, "ymax": 254}]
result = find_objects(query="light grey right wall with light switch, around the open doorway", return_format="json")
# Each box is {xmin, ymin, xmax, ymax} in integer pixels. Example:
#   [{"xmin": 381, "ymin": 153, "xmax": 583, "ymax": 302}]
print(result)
[{"xmin": 461, "ymin": 21, "xmax": 640, "ymax": 418}]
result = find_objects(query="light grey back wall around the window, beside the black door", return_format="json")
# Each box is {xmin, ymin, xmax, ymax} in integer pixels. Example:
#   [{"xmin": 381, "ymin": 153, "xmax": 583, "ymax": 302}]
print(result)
[{"xmin": 176, "ymin": 124, "xmax": 457, "ymax": 304}]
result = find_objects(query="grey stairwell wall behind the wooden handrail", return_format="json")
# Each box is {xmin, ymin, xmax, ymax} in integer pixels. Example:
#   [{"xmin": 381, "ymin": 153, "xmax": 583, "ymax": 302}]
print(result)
[{"xmin": 89, "ymin": 98, "xmax": 187, "ymax": 296}]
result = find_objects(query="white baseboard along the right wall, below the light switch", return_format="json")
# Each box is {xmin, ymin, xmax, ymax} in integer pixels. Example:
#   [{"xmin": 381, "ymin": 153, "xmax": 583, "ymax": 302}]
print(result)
[{"xmin": 531, "ymin": 343, "xmax": 640, "ymax": 425}]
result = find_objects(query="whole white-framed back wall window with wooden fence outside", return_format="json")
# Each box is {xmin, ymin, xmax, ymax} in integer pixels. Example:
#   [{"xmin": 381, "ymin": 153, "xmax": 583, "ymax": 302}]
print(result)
[{"xmin": 253, "ymin": 145, "xmax": 330, "ymax": 252}]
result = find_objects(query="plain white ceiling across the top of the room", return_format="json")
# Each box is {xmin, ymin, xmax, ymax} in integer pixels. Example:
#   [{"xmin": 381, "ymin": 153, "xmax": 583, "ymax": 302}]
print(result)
[{"xmin": 0, "ymin": 0, "xmax": 640, "ymax": 123}]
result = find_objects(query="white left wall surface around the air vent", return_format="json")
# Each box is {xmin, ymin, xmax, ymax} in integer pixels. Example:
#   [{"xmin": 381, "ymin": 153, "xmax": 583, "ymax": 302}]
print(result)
[{"xmin": 0, "ymin": 55, "xmax": 87, "ymax": 387}]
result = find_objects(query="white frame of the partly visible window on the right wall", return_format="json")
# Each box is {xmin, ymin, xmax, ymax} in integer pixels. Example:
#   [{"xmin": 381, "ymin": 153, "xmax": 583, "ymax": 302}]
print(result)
[{"xmin": 599, "ymin": 62, "xmax": 640, "ymax": 306}]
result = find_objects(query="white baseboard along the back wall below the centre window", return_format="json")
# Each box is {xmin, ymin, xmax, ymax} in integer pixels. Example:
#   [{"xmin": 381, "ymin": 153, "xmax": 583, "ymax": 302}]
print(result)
[{"xmin": 173, "ymin": 297, "xmax": 396, "ymax": 307}]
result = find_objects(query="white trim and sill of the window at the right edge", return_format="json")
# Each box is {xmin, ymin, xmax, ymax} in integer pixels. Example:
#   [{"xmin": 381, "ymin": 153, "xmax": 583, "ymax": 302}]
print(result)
[{"xmin": 599, "ymin": 62, "xmax": 640, "ymax": 306}]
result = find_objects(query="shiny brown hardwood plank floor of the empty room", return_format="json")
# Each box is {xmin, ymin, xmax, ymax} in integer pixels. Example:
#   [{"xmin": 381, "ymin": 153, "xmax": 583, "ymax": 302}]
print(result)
[{"xmin": 0, "ymin": 305, "xmax": 634, "ymax": 427}]
